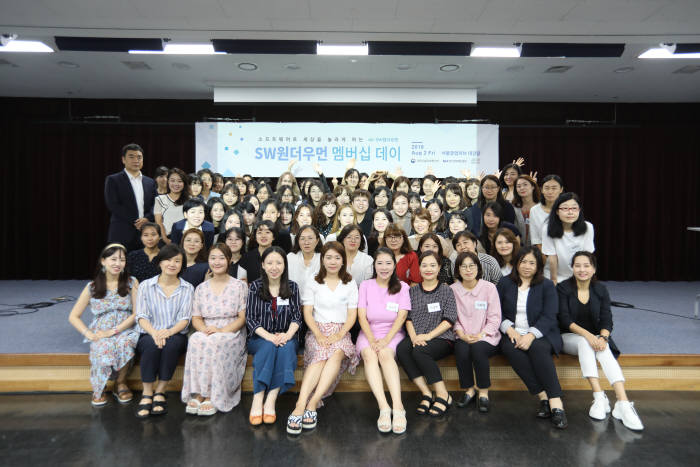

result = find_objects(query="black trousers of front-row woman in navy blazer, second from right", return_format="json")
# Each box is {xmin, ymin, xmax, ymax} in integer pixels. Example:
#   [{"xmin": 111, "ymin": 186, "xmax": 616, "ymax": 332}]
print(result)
[{"xmin": 501, "ymin": 334, "xmax": 561, "ymax": 398}]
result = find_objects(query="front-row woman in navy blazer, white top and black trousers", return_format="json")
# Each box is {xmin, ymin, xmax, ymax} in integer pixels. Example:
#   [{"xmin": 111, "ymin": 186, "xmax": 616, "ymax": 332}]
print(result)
[{"xmin": 497, "ymin": 247, "xmax": 568, "ymax": 429}]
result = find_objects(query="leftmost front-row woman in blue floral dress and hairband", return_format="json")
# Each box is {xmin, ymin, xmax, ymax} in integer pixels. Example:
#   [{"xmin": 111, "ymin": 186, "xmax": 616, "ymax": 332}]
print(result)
[{"xmin": 68, "ymin": 243, "xmax": 139, "ymax": 407}]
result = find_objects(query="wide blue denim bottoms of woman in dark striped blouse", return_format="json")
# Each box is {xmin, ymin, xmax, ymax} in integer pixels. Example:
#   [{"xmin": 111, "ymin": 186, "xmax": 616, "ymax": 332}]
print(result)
[{"xmin": 248, "ymin": 336, "xmax": 299, "ymax": 394}]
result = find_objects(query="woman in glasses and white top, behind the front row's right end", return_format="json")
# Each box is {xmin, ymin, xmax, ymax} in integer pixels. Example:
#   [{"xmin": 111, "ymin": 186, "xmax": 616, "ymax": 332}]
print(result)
[{"xmin": 542, "ymin": 192, "xmax": 595, "ymax": 284}]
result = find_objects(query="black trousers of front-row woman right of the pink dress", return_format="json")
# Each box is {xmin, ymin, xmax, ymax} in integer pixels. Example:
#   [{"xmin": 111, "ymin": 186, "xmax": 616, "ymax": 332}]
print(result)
[{"xmin": 396, "ymin": 336, "xmax": 452, "ymax": 384}]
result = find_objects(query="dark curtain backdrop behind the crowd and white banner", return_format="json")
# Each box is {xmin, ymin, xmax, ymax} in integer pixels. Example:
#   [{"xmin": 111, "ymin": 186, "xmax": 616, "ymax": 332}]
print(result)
[{"xmin": 0, "ymin": 99, "xmax": 700, "ymax": 280}]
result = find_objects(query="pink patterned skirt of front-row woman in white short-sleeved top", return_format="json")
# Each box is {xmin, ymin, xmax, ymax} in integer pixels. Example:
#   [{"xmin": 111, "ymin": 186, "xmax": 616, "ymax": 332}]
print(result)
[{"xmin": 304, "ymin": 323, "xmax": 360, "ymax": 398}]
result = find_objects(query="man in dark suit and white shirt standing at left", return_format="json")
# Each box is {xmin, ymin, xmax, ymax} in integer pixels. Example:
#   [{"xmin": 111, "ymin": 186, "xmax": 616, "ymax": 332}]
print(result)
[{"xmin": 105, "ymin": 143, "xmax": 156, "ymax": 251}]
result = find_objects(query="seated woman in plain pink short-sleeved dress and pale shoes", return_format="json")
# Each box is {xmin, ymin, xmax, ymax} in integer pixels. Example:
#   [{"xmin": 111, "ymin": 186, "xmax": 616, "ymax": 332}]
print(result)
[{"xmin": 357, "ymin": 247, "xmax": 411, "ymax": 434}]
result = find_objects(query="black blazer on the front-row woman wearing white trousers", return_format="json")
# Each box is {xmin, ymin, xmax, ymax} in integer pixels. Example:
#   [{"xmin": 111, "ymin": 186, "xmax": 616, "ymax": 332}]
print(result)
[{"xmin": 557, "ymin": 278, "xmax": 620, "ymax": 358}]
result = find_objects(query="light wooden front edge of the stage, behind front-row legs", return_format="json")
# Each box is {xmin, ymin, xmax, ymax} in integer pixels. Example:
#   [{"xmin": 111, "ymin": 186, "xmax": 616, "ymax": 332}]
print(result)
[{"xmin": 0, "ymin": 354, "xmax": 700, "ymax": 392}]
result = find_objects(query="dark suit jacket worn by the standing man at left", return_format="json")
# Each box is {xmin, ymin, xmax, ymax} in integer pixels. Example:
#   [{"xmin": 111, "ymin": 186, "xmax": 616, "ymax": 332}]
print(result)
[{"xmin": 105, "ymin": 170, "xmax": 157, "ymax": 243}]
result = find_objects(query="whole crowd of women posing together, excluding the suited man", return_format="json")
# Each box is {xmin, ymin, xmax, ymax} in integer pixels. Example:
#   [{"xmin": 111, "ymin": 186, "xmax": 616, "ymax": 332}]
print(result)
[{"xmin": 70, "ymin": 160, "xmax": 643, "ymax": 434}]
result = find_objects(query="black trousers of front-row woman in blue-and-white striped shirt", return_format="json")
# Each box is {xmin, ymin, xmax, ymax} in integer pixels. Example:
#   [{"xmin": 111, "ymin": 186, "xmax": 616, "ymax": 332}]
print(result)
[{"xmin": 136, "ymin": 334, "xmax": 187, "ymax": 383}]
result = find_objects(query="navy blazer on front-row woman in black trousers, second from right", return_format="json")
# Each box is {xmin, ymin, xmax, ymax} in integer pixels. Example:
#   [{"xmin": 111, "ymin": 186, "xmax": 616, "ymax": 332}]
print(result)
[{"xmin": 496, "ymin": 276, "xmax": 562, "ymax": 355}]
